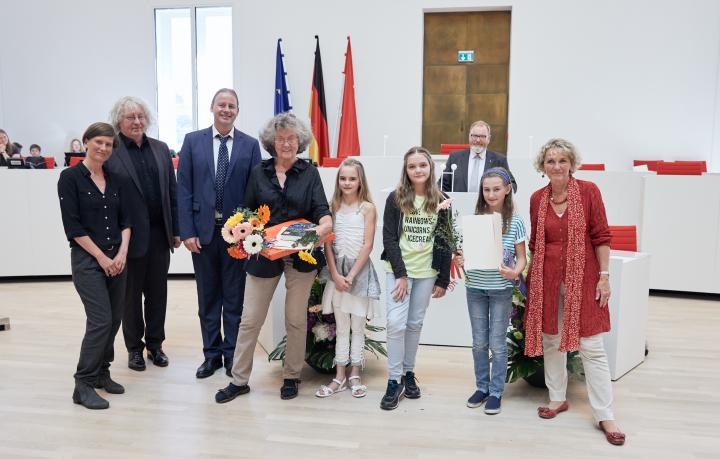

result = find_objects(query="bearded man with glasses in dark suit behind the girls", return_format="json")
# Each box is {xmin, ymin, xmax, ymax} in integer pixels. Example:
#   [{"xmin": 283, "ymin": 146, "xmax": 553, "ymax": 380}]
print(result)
[{"xmin": 440, "ymin": 120, "xmax": 517, "ymax": 193}]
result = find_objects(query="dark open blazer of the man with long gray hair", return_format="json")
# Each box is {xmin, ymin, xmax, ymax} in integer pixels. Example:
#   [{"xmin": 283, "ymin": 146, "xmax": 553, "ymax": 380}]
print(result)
[{"xmin": 106, "ymin": 137, "xmax": 179, "ymax": 258}]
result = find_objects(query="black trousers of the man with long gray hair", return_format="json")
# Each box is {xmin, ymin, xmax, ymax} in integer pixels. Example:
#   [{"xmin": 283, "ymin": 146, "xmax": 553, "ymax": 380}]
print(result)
[{"xmin": 122, "ymin": 223, "xmax": 170, "ymax": 352}]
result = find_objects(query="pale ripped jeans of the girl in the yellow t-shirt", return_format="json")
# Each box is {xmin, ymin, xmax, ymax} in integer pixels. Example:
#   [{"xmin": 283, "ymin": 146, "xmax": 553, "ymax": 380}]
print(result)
[{"xmin": 385, "ymin": 273, "xmax": 435, "ymax": 382}]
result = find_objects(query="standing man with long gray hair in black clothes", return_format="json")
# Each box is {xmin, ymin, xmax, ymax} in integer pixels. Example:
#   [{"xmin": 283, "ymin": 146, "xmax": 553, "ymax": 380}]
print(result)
[{"xmin": 107, "ymin": 96, "xmax": 180, "ymax": 371}]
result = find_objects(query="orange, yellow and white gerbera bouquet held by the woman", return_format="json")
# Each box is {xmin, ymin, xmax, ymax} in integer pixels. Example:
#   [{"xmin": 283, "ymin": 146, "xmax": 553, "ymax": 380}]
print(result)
[{"xmin": 221, "ymin": 205, "xmax": 318, "ymax": 265}]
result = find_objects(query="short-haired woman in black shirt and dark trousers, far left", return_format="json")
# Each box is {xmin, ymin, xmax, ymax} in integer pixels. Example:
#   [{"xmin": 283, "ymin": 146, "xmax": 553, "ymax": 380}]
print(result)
[{"xmin": 58, "ymin": 123, "xmax": 131, "ymax": 410}]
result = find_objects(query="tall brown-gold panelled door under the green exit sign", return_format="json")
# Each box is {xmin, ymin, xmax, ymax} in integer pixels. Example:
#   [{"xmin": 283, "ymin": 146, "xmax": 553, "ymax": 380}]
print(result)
[{"xmin": 422, "ymin": 11, "xmax": 510, "ymax": 154}]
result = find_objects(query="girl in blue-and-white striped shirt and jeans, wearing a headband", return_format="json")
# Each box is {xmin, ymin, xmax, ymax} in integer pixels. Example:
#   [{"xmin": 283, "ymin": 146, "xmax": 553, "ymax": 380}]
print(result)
[{"xmin": 455, "ymin": 167, "xmax": 527, "ymax": 414}]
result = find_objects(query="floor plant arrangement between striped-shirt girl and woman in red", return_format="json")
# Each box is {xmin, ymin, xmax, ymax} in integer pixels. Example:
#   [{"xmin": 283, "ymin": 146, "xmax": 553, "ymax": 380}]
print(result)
[{"xmin": 505, "ymin": 268, "xmax": 584, "ymax": 387}]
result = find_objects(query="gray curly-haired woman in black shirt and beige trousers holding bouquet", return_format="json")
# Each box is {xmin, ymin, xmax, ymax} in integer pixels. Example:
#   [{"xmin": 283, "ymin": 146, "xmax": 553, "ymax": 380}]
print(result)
[{"xmin": 215, "ymin": 113, "xmax": 332, "ymax": 403}]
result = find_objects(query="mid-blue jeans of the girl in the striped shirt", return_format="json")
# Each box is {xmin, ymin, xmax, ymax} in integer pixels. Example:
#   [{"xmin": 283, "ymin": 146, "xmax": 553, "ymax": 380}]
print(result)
[{"xmin": 467, "ymin": 287, "xmax": 513, "ymax": 398}]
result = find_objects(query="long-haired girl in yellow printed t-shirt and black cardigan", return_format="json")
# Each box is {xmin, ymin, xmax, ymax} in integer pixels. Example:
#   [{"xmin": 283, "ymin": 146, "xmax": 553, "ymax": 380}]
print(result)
[{"xmin": 380, "ymin": 147, "xmax": 451, "ymax": 410}]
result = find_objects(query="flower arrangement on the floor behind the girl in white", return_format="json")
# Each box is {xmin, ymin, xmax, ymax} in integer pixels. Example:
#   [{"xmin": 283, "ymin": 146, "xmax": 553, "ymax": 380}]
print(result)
[{"xmin": 268, "ymin": 278, "xmax": 387, "ymax": 373}]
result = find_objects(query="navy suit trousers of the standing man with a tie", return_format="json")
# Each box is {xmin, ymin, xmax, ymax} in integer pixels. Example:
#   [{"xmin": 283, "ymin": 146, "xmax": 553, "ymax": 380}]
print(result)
[{"xmin": 192, "ymin": 226, "xmax": 245, "ymax": 362}]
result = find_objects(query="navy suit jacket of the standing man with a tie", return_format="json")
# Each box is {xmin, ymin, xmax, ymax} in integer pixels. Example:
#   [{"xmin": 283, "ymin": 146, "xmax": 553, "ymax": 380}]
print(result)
[{"xmin": 178, "ymin": 126, "xmax": 260, "ymax": 244}]
